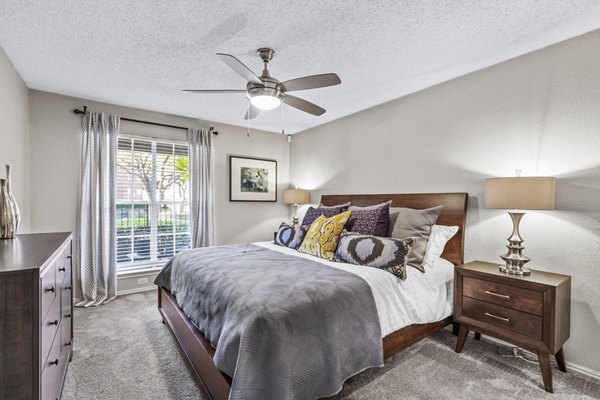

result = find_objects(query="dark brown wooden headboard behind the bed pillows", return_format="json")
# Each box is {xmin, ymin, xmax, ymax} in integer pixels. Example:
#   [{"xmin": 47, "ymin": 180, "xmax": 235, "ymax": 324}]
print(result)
[{"xmin": 321, "ymin": 193, "xmax": 469, "ymax": 265}]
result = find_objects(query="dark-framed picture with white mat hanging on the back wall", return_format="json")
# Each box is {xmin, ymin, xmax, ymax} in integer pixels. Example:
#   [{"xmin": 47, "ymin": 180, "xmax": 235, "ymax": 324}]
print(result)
[{"xmin": 229, "ymin": 156, "xmax": 277, "ymax": 201}]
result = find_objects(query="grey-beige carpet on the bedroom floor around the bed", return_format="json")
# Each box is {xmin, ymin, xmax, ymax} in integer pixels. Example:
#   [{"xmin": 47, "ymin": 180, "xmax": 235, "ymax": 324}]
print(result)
[{"xmin": 62, "ymin": 292, "xmax": 600, "ymax": 400}]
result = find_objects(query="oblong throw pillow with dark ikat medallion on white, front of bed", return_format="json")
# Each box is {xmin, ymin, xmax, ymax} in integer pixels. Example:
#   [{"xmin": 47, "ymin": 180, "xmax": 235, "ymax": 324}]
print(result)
[{"xmin": 335, "ymin": 232, "xmax": 414, "ymax": 280}]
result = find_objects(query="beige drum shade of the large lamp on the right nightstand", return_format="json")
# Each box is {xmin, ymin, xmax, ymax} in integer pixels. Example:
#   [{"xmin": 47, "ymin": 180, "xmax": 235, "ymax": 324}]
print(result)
[{"xmin": 485, "ymin": 176, "xmax": 556, "ymax": 210}]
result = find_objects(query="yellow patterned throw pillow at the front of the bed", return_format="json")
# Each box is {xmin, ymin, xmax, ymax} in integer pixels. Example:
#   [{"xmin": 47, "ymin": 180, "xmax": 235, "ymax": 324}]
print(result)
[{"xmin": 298, "ymin": 211, "xmax": 350, "ymax": 260}]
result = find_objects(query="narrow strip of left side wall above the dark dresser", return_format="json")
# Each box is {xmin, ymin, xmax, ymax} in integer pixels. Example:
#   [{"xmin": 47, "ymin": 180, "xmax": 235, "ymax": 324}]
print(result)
[{"xmin": 0, "ymin": 48, "xmax": 30, "ymax": 233}]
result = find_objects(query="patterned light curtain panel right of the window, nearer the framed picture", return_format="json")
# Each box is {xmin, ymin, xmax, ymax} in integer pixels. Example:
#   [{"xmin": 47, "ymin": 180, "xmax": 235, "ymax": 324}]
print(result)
[{"xmin": 188, "ymin": 129, "xmax": 215, "ymax": 247}]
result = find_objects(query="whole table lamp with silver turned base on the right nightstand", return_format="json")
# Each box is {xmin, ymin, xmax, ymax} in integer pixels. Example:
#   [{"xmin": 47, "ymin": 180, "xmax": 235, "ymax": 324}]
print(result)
[{"xmin": 485, "ymin": 176, "xmax": 556, "ymax": 275}]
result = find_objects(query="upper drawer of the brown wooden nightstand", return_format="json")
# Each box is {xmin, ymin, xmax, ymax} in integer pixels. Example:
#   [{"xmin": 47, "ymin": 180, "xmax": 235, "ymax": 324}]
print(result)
[{"xmin": 463, "ymin": 276, "xmax": 543, "ymax": 316}]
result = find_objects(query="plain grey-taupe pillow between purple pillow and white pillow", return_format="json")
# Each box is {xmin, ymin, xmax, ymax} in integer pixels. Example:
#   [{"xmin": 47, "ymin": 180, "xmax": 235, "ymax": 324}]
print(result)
[{"xmin": 390, "ymin": 206, "xmax": 442, "ymax": 272}]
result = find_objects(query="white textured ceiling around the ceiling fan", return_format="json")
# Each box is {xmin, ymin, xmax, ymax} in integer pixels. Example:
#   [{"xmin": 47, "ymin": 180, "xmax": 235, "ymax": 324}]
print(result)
[{"xmin": 0, "ymin": 0, "xmax": 600, "ymax": 133}]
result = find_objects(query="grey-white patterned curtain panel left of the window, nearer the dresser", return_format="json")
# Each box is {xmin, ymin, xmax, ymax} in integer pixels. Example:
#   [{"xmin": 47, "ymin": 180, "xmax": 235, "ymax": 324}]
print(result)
[{"xmin": 75, "ymin": 112, "xmax": 120, "ymax": 307}]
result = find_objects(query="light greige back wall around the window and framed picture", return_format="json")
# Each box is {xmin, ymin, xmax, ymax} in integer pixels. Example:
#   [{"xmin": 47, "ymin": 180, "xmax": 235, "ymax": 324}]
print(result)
[{"xmin": 30, "ymin": 90, "xmax": 289, "ymax": 290}]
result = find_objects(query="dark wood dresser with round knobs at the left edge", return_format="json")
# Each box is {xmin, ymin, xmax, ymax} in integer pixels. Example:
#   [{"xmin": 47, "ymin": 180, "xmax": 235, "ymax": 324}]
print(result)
[{"xmin": 0, "ymin": 232, "xmax": 73, "ymax": 400}]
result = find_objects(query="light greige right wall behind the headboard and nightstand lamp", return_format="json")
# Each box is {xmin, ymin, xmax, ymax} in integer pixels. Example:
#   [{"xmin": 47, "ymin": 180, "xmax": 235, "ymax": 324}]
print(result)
[{"xmin": 290, "ymin": 31, "xmax": 600, "ymax": 371}]
